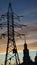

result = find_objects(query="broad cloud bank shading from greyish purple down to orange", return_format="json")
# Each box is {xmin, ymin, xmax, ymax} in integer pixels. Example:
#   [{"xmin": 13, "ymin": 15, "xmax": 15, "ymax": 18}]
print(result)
[{"xmin": 0, "ymin": 13, "xmax": 37, "ymax": 53}]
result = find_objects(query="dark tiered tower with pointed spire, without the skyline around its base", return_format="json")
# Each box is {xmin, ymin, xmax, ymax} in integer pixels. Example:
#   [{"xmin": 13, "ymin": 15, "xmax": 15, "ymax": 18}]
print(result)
[{"xmin": 23, "ymin": 41, "xmax": 30, "ymax": 63}]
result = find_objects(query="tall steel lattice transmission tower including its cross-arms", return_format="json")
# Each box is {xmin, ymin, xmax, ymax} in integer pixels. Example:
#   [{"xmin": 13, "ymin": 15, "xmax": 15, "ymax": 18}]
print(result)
[{"xmin": 0, "ymin": 3, "xmax": 27, "ymax": 65}]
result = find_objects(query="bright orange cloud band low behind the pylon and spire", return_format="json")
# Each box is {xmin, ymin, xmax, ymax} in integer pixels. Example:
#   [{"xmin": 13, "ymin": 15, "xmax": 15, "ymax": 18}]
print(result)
[{"xmin": 0, "ymin": 40, "xmax": 37, "ymax": 53}]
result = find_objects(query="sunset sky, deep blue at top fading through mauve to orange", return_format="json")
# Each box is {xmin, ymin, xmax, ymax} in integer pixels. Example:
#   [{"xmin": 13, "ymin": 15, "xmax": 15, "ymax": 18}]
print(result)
[{"xmin": 0, "ymin": 0, "xmax": 37, "ymax": 64}]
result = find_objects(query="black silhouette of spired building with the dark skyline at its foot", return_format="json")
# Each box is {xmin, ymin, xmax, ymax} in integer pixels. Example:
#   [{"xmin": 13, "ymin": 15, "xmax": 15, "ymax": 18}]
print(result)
[{"xmin": 20, "ymin": 41, "xmax": 37, "ymax": 65}]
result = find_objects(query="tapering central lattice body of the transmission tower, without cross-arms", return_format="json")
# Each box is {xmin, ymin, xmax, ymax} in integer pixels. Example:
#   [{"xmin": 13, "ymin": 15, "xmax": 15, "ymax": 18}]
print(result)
[{"xmin": 4, "ymin": 3, "xmax": 20, "ymax": 65}]
